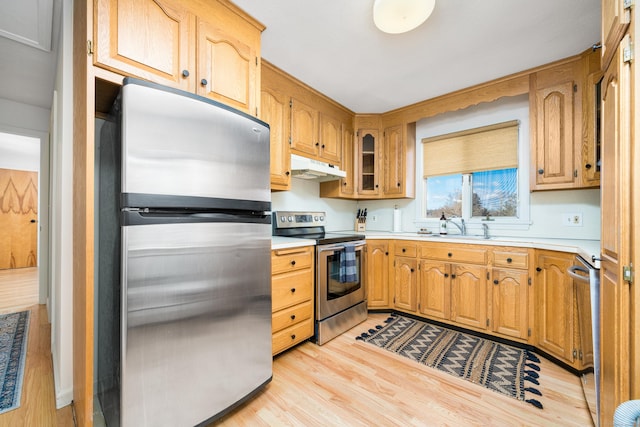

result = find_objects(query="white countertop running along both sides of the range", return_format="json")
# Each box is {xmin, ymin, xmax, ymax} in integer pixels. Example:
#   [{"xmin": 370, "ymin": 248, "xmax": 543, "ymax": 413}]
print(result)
[{"xmin": 271, "ymin": 230, "xmax": 600, "ymax": 268}]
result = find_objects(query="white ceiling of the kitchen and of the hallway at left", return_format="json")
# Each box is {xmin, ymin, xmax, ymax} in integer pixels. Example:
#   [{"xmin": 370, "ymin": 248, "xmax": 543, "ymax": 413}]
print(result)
[{"xmin": 0, "ymin": 0, "xmax": 600, "ymax": 113}]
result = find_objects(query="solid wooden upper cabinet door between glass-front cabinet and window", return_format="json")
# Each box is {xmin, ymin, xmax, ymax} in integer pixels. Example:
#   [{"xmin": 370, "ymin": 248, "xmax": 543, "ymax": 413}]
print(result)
[{"xmin": 382, "ymin": 125, "xmax": 404, "ymax": 197}]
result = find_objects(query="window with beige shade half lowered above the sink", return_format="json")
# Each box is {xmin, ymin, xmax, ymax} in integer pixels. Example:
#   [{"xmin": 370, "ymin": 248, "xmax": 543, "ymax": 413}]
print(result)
[{"xmin": 422, "ymin": 121, "xmax": 519, "ymax": 219}]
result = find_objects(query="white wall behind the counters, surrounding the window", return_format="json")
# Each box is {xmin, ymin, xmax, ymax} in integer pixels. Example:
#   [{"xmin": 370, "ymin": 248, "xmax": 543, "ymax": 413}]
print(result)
[{"xmin": 272, "ymin": 95, "xmax": 600, "ymax": 244}]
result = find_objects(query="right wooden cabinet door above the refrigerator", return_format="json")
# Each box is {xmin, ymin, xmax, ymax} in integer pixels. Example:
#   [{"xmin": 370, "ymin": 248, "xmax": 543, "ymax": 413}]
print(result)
[{"xmin": 196, "ymin": 19, "xmax": 260, "ymax": 116}]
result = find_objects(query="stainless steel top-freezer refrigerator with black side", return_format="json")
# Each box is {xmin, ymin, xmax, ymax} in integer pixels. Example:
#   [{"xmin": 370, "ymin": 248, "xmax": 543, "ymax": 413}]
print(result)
[{"xmin": 96, "ymin": 79, "xmax": 272, "ymax": 427}]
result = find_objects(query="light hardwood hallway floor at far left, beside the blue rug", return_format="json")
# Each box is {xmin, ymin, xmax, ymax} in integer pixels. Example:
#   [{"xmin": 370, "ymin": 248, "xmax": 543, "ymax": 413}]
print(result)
[{"xmin": 0, "ymin": 268, "xmax": 74, "ymax": 427}]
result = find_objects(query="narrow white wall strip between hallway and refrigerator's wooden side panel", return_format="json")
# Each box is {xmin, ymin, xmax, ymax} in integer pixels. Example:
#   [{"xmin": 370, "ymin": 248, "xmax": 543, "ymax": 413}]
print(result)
[{"xmin": 50, "ymin": 0, "xmax": 73, "ymax": 408}]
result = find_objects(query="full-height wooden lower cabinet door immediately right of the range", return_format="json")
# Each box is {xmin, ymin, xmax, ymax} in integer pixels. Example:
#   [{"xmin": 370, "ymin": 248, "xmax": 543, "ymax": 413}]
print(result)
[{"xmin": 366, "ymin": 240, "xmax": 389, "ymax": 308}]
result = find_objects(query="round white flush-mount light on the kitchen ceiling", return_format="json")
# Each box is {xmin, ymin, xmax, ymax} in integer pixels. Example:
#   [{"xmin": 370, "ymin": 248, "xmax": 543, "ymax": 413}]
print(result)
[{"xmin": 373, "ymin": 0, "xmax": 436, "ymax": 34}]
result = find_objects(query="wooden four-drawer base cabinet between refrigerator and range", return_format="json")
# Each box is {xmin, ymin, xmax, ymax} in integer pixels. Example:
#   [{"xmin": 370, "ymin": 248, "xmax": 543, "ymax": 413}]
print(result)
[{"xmin": 271, "ymin": 246, "xmax": 314, "ymax": 355}]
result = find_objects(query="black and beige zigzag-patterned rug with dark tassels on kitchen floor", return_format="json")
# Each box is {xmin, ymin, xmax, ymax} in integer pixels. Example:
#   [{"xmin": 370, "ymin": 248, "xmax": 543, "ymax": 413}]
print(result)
[{"xmin": 356, "ymin": 314, "xmax": 542, "ymax": 409}]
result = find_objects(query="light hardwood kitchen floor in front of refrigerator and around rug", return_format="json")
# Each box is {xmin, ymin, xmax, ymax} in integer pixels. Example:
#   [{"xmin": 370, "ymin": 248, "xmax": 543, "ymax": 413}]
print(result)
[{"xmin": 215, "ymin": 314, "xmax": 592, "ymax": 426}]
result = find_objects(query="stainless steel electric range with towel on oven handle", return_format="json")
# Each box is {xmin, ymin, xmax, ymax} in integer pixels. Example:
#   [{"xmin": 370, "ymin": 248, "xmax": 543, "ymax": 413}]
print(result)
[{"xmin": 273, "ymin": 211, "xmax": 367, "ymax": 345}]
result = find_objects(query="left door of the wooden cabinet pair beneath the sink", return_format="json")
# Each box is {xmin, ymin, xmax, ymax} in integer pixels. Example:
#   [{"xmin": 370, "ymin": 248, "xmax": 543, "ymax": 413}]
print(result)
[{"xmin": 418, "ymin": 260, "xmax": 451, "ymax": 320}]
